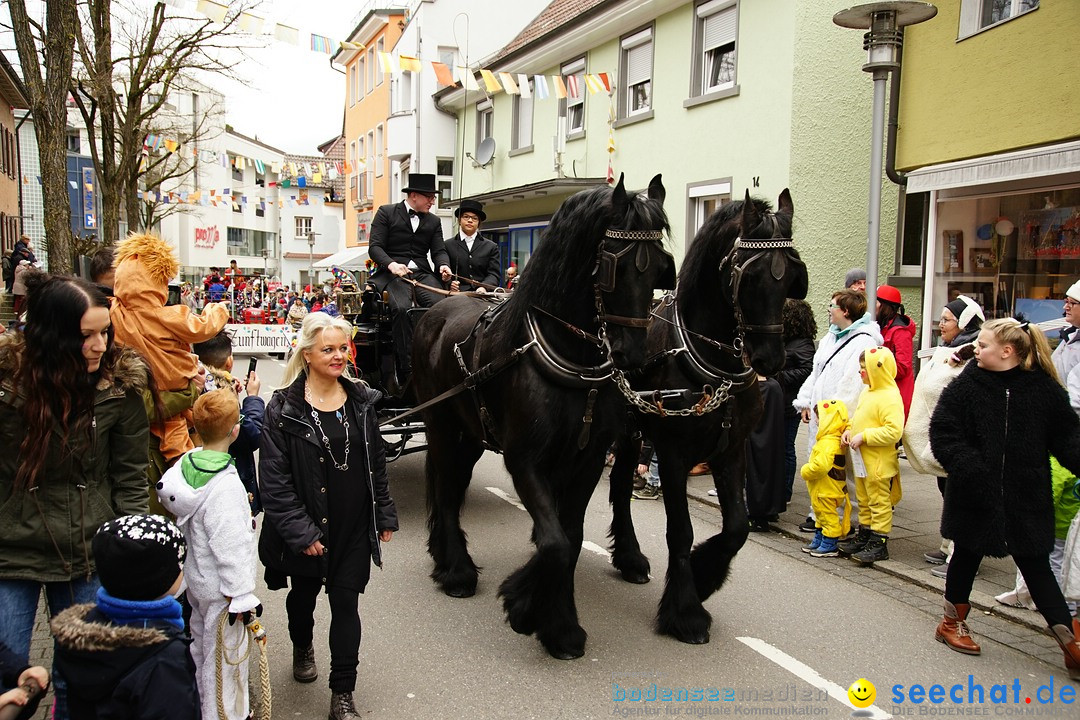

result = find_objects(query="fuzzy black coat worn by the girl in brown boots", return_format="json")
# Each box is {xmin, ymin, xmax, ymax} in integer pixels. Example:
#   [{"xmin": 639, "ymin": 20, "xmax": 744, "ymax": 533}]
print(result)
[{"xmin": 930, "ymin": 363, "xmax": 1080, "ymax": 557}]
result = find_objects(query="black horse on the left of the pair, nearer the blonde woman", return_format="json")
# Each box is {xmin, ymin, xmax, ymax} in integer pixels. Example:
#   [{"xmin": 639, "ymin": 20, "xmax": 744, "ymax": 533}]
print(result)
[{"xmin": 413, "ymin": 175, "xmax": 675, "ymax": 658}]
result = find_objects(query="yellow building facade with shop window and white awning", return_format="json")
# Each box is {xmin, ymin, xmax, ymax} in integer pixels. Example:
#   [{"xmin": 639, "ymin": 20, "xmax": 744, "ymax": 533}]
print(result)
[{"xmin": 896, "ymin": 0, "xmax": 1080, "ymax": 347}]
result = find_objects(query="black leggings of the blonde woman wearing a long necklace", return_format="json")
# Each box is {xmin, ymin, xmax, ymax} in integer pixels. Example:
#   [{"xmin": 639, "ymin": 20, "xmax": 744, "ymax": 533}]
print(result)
[{"xmin": 285, "ymin": 575, "xmax": 361, "ymax": 693}]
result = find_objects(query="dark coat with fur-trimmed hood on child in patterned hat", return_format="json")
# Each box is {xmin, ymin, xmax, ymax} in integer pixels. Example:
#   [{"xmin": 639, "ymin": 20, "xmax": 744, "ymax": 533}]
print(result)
[{"xmin": 52, "ymin": 604, "xmax": 200, "ymax": 720}]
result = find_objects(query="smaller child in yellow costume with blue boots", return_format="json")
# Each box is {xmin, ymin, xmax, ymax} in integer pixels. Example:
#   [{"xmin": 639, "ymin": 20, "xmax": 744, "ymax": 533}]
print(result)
[{"xmin": 799, "ymin": 399, "xmax": 851, "ymax": 557}]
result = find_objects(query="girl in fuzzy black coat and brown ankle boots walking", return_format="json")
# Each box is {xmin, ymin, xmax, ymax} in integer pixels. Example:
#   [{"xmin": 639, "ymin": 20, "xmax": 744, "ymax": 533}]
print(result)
[{"xmin": 930, "ymin": 317, "xmax": 1080, "ymax": 680}]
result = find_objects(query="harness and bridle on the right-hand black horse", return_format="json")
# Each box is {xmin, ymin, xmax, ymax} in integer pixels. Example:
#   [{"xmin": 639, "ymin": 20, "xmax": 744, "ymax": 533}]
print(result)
[{"xmin": 615, "ymin": 229, "xmax": 795, "ymax": 418}]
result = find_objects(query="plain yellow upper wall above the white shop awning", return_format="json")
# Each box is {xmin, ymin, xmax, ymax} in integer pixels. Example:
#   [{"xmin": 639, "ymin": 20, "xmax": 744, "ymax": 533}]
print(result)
[{"xmin": 896, "ymin": 0, "xmax": 1080, "ymax": 169}]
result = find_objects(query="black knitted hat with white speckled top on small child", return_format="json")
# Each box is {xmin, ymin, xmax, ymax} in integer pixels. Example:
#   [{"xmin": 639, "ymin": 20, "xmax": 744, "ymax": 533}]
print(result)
[{"xmin": 93, "ymin": 515, "xmax": 187, "ymax": 600}]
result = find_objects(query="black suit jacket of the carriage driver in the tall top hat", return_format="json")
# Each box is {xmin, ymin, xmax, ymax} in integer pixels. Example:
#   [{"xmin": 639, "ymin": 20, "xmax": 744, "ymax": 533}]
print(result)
[{"xmin": 367, "ymin": 203, "xmax": 450, "ymax": 273}]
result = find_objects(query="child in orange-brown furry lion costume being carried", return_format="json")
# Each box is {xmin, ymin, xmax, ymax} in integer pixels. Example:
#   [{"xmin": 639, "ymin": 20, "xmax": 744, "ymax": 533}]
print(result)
[{"xmin": 110, "ymin": 233, "xmax": 229, "ymax": 464}]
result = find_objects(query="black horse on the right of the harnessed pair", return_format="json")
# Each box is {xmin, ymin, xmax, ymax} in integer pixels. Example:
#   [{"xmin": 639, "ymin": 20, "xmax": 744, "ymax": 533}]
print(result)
[{"xmin": 610, "ymin": 190, "xmax": 808, "ymax": 643}]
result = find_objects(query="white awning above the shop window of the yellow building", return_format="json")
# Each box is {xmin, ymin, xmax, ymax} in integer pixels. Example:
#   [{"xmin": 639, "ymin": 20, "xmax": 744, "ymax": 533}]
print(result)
[{"xmin": 907, "ymin": 141, "xmax": 1080, "ymax": 194}]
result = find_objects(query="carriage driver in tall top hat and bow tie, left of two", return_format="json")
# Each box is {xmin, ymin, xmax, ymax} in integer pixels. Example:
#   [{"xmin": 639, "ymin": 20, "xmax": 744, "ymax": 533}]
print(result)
[{"xmin": 367, "ymin": 173, "xmax": 451, "ymax": 388}]
